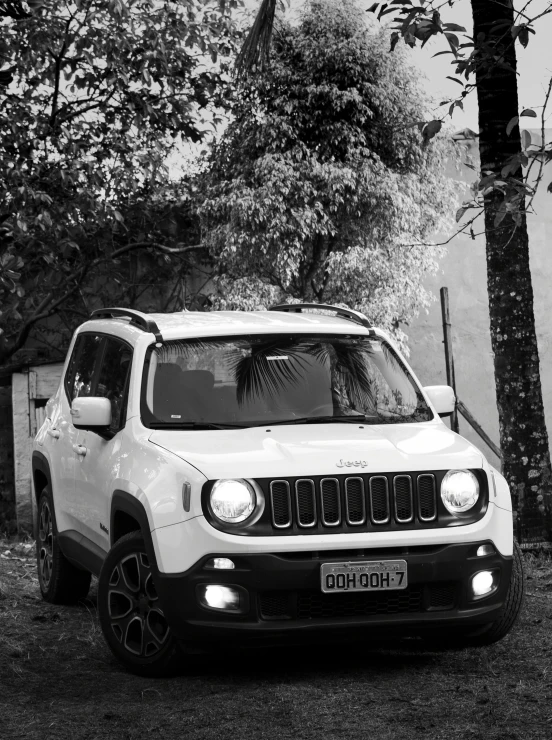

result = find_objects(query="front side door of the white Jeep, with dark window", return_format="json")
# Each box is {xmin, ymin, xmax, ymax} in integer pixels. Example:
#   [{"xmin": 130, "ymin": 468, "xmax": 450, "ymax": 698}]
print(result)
[{"xmin": 75, "ymin": 337, "xmax": 132, "ymax": 551}]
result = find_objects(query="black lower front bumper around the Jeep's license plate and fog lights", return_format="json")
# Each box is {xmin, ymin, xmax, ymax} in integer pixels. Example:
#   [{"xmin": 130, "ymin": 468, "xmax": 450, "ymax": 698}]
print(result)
[{"xmin": 157, "ymin": 540, "xmax": 512, "ymax": 646}]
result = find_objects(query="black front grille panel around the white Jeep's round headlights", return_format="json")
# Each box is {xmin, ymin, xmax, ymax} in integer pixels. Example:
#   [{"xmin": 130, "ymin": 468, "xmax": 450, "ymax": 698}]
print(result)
[{"xmin": 201, "ymin": 472, "xmax": 489, "ymax": 537}]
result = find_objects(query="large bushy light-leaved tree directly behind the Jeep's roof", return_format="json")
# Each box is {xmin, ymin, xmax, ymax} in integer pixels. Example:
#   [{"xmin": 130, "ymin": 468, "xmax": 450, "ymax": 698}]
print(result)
[{"xmin": 201, "ymin": 0, "xmax": 456, "ymax": 350}]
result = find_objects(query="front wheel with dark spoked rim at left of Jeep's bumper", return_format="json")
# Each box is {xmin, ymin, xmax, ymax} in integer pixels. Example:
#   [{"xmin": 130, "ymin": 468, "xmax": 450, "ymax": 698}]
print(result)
[{"xmin": 98, "ymin": 532, "xmax": 180, "ymax": 677}]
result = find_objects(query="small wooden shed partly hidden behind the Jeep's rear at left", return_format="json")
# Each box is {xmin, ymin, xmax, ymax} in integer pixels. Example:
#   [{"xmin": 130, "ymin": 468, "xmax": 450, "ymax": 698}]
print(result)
[{"xmin": 12, "ymin": 362, "xmax": 63, "ymax": 532}]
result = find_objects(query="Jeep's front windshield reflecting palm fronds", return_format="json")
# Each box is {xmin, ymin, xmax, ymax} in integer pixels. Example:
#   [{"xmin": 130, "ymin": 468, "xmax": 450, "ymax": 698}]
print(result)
[{"xmin": 142, "ymin": 334, "xmax": 433, "ymax": 429}]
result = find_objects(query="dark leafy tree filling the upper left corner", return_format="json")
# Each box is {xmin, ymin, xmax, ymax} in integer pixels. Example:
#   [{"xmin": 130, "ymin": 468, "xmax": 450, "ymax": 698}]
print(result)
[{"xmin": 0, "ymin": 0, "xmax": 242, "ymax": 364}]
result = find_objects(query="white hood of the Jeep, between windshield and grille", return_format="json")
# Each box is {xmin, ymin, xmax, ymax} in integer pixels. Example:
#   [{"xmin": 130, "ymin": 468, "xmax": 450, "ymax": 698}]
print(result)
[{"xmin": 149, "ymin": 421, "xmax": 483, "ymax": 480}]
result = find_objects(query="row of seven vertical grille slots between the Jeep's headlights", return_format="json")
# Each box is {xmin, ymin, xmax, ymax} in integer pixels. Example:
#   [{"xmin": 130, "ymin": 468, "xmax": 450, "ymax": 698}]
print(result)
[{"xmin": 269, "ymin": 473, "xmax": 437, "ymax": 531}]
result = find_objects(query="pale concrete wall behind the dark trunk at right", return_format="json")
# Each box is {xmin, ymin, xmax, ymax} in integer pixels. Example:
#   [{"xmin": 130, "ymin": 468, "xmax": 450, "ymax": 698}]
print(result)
[{"xmin": 406, "ymin": 139, "xmax": 552, "ymax": 465}]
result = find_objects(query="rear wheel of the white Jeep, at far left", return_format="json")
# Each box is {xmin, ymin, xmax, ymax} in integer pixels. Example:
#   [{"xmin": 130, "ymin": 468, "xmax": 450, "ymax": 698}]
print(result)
[{"xmin": 36, "ymin": 486, "xmax": 92, "ymax": 604}]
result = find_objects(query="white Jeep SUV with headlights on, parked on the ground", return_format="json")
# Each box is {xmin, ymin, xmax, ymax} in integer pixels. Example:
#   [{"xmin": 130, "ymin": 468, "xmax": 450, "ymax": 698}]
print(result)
[{"xmin": 32, "ymin": 304, "xmax": 523, "ymax": 675}]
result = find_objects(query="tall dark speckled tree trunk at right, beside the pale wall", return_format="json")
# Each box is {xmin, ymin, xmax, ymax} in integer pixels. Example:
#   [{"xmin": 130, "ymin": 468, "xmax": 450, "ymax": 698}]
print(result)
[{"xmin": 471, "ymin": 0, "xmax": 552, "ymax": 541}]
